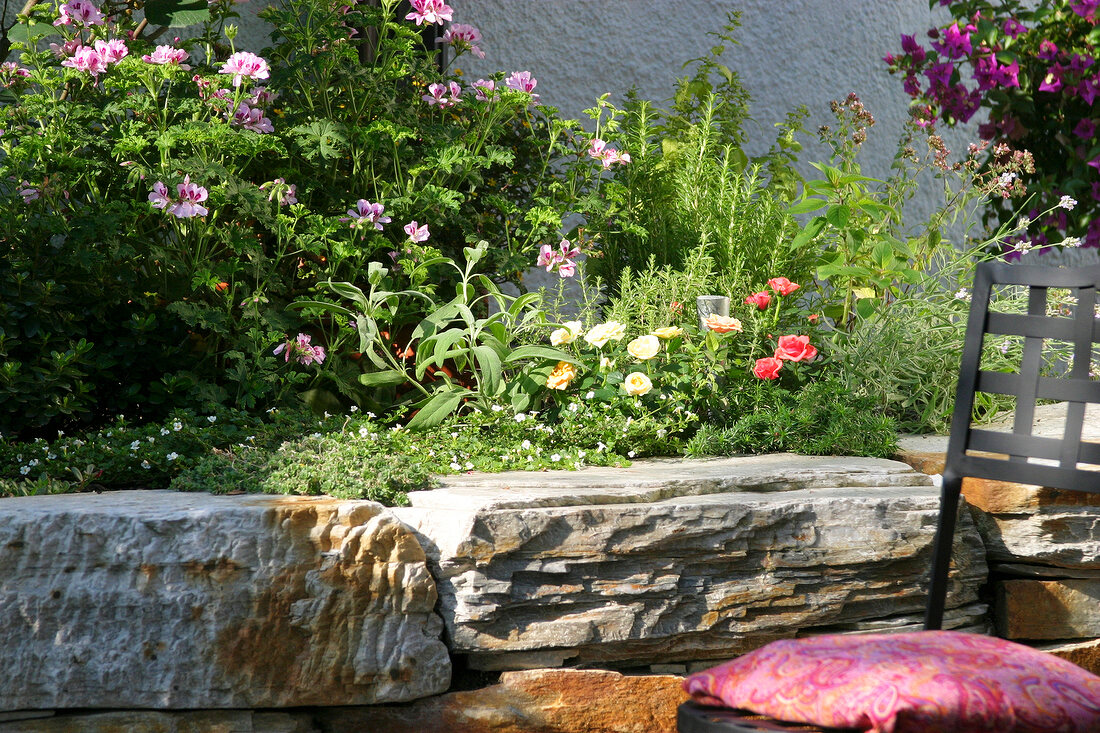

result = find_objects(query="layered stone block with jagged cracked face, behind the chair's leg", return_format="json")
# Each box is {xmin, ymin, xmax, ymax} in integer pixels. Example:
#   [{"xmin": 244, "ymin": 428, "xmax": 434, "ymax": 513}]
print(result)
[{"xmin": 394, "ymin": 455, "xmax": 987, "ymax": 669}]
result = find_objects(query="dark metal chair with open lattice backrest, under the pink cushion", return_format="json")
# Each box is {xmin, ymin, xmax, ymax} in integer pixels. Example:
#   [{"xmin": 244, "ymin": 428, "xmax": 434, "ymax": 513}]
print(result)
[{"xmin": 678, "ymin": 263, "xmax": 1100, "ymax": 733}]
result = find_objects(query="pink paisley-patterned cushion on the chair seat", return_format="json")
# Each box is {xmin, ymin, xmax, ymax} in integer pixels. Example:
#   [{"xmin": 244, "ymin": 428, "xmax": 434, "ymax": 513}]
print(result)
[{"xmin": 684, "ymin": 632, "xmax": 1100, "ymax": 733}]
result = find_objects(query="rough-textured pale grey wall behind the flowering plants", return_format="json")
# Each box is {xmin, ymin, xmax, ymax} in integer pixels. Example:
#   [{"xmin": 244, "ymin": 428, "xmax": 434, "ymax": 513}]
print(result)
[{"xmin": 451, "ymin": 0, "xmax": 974, "ymax": 191}]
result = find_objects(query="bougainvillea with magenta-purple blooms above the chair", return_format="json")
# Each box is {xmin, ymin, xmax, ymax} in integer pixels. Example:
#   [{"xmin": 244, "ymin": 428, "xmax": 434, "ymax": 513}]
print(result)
[{"xmin": 884, "ymin": 0, "xmax": 1100, "ymax": 248}]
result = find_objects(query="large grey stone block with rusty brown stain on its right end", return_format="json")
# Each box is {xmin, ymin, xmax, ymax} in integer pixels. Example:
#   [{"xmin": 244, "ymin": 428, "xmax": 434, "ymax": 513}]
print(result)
[{"xmin": 0, "ymin": 491, "xmax": 450, "ymax": 708}]
